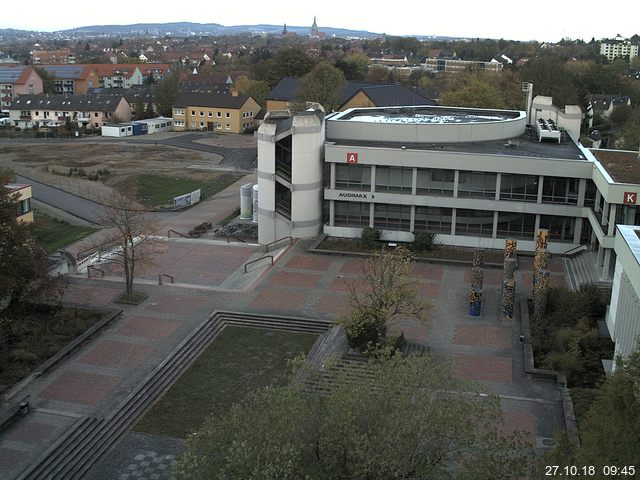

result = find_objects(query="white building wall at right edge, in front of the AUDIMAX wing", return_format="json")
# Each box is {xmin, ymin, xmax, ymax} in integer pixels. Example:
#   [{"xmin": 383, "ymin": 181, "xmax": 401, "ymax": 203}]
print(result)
[{"xmin": 607, "ymin": 225, "xmax": 640, "ymax": 368}]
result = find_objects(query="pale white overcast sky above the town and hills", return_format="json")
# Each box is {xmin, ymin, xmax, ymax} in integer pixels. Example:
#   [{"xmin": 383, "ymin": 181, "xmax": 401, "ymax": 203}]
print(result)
[{"xmin": 0, "ymin": 0, "xmax": 640, "ymax": 41}]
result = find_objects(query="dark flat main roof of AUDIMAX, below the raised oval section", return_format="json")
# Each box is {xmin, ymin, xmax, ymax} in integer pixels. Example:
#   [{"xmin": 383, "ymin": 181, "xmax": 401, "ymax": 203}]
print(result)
[{"xmin": 327, "ymin": 129, "xmax": 592, "ymax": 162}]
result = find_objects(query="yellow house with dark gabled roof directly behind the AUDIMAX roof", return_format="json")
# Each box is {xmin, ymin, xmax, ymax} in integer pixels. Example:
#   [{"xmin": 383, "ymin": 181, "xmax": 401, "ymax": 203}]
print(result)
[{"xmin": 265, "ymin": 77, "xmax": 436, "ymax": 112}]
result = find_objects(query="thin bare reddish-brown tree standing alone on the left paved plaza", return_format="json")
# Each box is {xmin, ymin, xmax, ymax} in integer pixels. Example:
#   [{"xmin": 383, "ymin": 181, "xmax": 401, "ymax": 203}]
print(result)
[{"xmin": 101, "ymin": 186, "xmax": 156, "ymax": 300}]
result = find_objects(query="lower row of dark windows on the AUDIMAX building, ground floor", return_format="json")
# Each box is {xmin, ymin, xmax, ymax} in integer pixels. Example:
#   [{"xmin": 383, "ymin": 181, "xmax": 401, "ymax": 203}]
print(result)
[{"xmin": 334, "ymin": 201, "xmax": 575, "ymax": 243}]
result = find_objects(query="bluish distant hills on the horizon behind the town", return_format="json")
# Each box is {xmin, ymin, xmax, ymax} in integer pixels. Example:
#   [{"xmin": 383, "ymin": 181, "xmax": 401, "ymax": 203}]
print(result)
[{"xmin": 0, "ymin": 22, "xmax": 446, "ymax": 38}]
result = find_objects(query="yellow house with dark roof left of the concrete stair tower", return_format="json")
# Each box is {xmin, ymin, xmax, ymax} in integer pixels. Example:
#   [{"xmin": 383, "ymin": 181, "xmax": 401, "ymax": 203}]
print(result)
[{"xmin": 173, "ymin": 92, "xmax": 260, "ymax": 133}]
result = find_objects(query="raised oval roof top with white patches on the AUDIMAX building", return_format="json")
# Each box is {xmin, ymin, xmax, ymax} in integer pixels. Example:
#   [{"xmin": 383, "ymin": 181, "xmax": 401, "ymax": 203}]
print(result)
[{"xmin": 331, "ymin": 105, "xmax": 521, "ymax": 124}]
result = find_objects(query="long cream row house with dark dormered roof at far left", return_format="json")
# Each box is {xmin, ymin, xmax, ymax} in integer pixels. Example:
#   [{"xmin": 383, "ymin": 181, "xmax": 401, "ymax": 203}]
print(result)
[{"xmin": 9, "ymin": 95, "xmax": 131, "ymax": 129}]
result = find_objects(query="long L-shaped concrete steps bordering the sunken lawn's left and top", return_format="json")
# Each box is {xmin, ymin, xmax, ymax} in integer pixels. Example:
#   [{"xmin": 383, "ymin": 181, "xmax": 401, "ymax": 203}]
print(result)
[{"xmin": 17, "ymin": 312, "xmax": 331, "ymax": 480}]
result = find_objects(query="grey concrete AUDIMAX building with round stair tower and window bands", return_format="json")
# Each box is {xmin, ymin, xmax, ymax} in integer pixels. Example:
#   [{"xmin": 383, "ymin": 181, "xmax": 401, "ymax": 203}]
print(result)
[{"xmin": 258, "ymin": 106, "xmax": 640, "ymax": 288}]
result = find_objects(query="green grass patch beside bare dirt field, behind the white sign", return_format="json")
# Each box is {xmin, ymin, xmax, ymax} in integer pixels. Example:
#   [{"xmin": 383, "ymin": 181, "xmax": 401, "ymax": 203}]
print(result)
[{"xmin": 121, "ymin": 172, "xmax": 240, "ymax": 207}]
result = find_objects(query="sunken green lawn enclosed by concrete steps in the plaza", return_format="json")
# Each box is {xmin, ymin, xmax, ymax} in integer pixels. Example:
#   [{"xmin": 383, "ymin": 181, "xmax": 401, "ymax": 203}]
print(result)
[{"xmin": 134, "ymin": 327, "xmax": 317, "ymax": 438}]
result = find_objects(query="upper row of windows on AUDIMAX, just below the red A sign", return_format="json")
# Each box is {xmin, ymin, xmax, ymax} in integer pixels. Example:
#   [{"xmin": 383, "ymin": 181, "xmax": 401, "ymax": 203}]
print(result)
[{"xmin": 335, "ymin": 164, "xmax": 589, "ymax": 205}]
